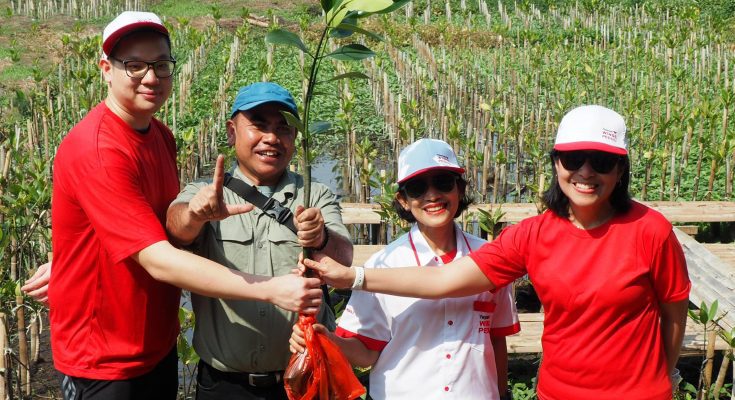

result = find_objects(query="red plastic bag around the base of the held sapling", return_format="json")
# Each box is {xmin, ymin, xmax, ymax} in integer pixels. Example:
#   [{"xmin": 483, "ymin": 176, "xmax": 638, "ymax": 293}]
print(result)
[{"xmin": 283, "ymin": 315, "xmax": 365, "ymax": 400}]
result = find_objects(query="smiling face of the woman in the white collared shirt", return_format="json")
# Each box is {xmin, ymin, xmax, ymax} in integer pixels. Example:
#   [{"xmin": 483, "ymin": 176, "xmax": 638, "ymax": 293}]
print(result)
[{"xmin": 396, "ymin": 170, "xmax": 464, "ymax": 230}]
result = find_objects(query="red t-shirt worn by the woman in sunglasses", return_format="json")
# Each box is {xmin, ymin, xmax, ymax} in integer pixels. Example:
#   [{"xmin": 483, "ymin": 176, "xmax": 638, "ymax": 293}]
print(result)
[{"xmin": 470, "ymin": 203, "xmax": 691, "ymax": 400}]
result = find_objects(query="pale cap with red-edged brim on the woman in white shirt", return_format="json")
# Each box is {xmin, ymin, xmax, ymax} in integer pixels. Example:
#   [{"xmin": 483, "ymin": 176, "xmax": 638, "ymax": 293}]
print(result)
[{"xmin": 398, "ymin": 139, "xmax": 464, "ymax": 183}]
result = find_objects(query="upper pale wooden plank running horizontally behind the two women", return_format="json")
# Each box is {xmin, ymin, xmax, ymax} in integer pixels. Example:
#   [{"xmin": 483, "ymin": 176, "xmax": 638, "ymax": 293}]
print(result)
[{"xmin": 341, "ymin": 201, "xmax": 735, "ymax": 224}]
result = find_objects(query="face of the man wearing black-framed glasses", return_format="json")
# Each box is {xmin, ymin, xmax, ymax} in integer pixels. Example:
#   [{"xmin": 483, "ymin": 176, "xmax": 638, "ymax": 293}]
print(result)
[{"xmin": 100, "ymin": 31, "xmax": 173, "ymax": 129}]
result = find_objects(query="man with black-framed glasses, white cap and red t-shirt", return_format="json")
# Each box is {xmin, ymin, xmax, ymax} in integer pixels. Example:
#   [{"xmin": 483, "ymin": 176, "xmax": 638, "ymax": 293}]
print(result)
[{"xmin": 26, "ymin": 12, "xmax": 321, "ymax": 400}]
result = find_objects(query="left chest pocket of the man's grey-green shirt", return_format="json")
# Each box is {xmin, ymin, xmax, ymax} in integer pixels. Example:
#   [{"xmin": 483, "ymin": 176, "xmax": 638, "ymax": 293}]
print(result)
[{"xmin": 213, "ymin": 215, "xmax": 254, "ymax": 274}]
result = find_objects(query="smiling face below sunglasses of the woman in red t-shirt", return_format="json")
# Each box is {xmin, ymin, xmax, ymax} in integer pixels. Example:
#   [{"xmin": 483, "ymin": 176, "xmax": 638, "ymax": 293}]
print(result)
[{"xmin": 554, "ymin": 152, "xmax": 623, "ymax": 215}]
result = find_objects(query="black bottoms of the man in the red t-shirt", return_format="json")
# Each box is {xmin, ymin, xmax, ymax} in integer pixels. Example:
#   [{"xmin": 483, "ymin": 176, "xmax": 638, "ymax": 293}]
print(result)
[{"xmin": 61, "ymin": 347, "xmax": 179, "ymax": 400}]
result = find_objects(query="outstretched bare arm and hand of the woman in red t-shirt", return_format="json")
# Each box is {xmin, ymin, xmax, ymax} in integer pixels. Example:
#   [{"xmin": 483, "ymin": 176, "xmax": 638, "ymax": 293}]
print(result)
[{"xmin": 302, "ymin": 257, "xmax": 495, "ymax": 299}]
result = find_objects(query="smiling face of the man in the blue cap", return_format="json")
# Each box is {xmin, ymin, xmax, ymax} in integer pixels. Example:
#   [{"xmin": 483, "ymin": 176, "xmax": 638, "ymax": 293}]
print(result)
[{"xmin": 227, "ymin": 103, "xmax": 296, "ymax": 186}]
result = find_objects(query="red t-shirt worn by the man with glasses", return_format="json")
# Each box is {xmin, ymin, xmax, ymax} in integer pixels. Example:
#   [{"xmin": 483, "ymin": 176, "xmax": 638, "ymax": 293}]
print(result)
[{"xmin": 49, "ymin": 102, "xmax": 180, "ymax": 380}]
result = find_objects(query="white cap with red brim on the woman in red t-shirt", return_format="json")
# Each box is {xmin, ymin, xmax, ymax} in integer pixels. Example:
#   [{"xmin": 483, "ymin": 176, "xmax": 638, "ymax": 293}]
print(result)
[{"xmin": 554, "ymin": 105, "xmax": 628, "ymax": 155}]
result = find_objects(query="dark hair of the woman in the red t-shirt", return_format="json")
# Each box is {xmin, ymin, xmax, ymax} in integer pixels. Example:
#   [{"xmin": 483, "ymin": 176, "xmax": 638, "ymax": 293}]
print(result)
[{"xmin": 543, "ymin": 150, "xmax": 632, "ymax": 218}]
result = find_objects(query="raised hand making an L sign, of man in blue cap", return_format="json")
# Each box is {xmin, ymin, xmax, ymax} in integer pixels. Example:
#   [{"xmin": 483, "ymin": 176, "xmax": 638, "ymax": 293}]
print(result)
[{"xmin": 166, "ymin": 154, "xmax": 253, "ymax": 246}]
